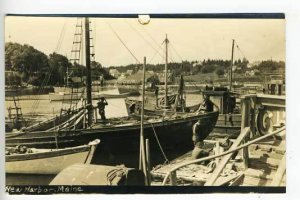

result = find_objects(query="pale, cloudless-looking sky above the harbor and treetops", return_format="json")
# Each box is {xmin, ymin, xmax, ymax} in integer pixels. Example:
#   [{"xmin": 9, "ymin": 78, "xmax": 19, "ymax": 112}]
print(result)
[{"xmin": 5, "ymin": 16, "xmax": 285, "ymax": 67}]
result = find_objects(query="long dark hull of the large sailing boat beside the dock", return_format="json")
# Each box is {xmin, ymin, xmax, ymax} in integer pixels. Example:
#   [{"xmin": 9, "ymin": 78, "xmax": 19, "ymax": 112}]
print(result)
[{"xmin": 6, "ymin": 112, "xmax": 218, "ymax": 167}]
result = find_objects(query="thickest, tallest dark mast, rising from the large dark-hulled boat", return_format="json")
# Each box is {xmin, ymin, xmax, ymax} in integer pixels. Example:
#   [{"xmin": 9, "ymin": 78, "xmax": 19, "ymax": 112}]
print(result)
[{"xmin": 85, "ymin": 17, "xmax": 93, "ymax": 126}]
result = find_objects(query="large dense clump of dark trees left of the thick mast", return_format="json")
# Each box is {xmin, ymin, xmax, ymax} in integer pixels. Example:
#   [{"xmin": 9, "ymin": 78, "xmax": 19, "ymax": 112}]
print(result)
[{"xmin": 5, "ymin": 42, "xmax": 112, "ymax": 86}]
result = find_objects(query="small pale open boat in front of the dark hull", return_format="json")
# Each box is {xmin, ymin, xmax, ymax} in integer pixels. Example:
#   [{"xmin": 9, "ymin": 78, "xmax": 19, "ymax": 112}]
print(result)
[{"xmin": 5, "ymin": 139, "xmax": 100, "ymax": 174}]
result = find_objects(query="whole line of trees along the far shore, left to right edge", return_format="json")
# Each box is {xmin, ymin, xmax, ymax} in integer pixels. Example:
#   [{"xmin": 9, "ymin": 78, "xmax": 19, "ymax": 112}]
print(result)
[{"xmin": 5, "ymin": 42, "xmax": 285, "ymax": 86}]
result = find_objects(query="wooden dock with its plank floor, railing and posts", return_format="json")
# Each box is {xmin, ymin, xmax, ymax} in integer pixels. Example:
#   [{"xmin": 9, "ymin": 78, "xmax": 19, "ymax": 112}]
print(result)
[{"xmin": 151, "ymin": 95, "xmax": 286, "ymax": 187}]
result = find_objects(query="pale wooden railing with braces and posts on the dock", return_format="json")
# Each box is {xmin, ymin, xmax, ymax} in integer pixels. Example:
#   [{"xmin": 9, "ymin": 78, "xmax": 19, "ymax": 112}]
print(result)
[{"xmin": 163, "ymin": 94, "xmax": 285, "ymax": 186}]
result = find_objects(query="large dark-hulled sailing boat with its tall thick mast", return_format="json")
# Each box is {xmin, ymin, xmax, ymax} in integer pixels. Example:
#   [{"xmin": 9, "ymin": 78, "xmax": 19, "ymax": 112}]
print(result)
[{"xmin": 6, "ymin": 18, "xmax": 219, "ymax": 167}]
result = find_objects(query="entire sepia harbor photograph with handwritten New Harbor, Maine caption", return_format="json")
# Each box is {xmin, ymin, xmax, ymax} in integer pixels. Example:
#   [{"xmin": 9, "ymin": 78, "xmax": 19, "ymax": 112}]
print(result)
[{"xmin": 4, "ymin": 13, "xmax": 287, "ymax": 194}]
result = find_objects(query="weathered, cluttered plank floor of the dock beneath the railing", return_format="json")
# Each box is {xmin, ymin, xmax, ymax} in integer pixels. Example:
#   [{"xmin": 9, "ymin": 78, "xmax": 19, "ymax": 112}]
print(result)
[{"xmin": 151, "ymin": 138, "xmax": 286, "ymax": 186}]
